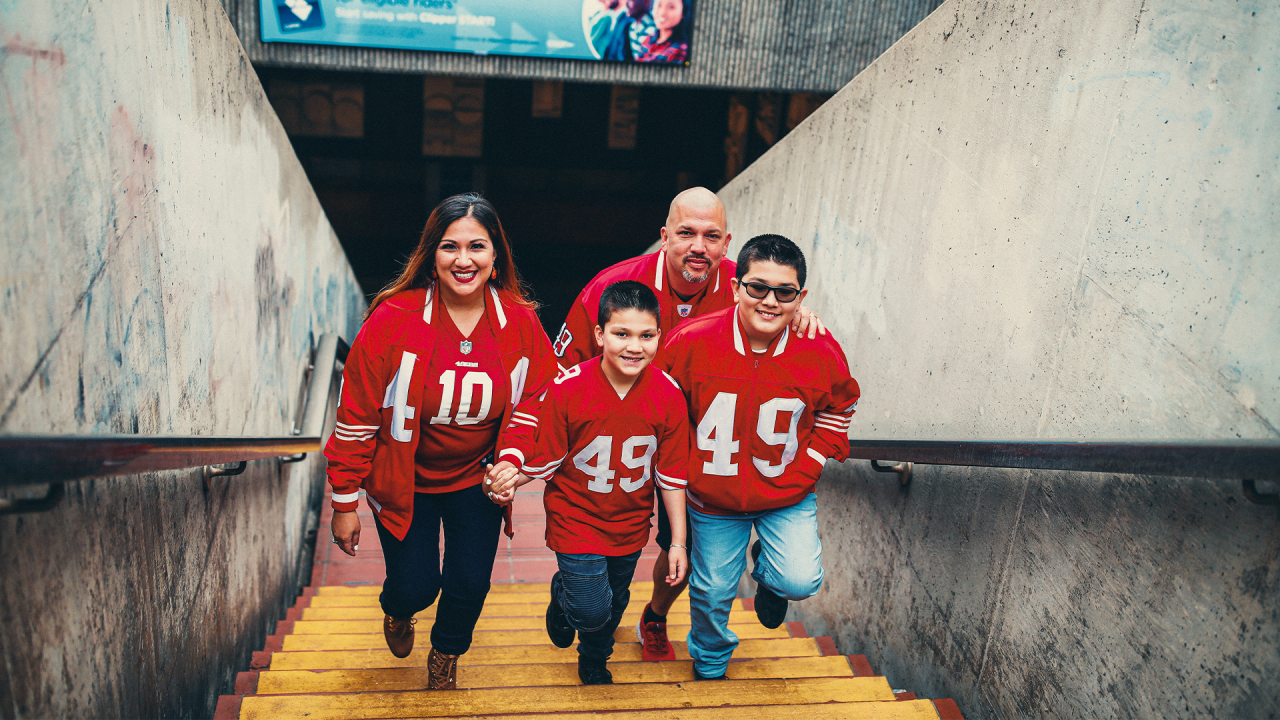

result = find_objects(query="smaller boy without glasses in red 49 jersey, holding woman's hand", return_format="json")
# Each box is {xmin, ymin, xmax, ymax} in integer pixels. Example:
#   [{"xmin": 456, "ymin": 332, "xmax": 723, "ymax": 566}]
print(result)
[{"xmin": 489, "ymin": 281, "xmax": 689, "ymax": 685}]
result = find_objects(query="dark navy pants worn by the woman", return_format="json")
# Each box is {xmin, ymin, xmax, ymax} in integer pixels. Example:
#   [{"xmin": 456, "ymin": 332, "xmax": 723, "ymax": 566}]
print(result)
[{"xmin": 374, "ymin": 486, "xmax": 502, "ymax": 655}]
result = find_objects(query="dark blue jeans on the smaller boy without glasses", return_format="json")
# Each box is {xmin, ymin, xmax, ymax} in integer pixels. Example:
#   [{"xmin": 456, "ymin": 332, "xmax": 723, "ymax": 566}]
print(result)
[{"xmin": 552, "ymin": 550, "xmax": 640, "ymax": 662}]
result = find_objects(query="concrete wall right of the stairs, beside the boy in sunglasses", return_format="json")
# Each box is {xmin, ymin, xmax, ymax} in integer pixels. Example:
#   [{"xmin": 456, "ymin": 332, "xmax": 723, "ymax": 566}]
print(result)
[{"xmin": 722, "ymin": 0, "xmax": 1280, "ymax": 719}]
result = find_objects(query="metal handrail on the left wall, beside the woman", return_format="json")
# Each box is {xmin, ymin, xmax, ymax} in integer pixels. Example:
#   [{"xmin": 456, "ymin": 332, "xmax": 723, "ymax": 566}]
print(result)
[{"xmin": 0, "ymin": 334, "xmax": 349, "ymax": 515}]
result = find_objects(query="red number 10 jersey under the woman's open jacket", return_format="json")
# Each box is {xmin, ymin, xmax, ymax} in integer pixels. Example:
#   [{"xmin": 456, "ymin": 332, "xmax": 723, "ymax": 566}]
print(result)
[{"xmin": 413, "ymin": 305, "xmax": 508, "ymax": 492}]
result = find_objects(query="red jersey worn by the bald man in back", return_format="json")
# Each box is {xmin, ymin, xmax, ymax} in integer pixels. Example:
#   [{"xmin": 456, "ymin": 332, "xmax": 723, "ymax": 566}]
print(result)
[{"xmin": 552, "ymin": 250, "xmax": 737, "ymax": 368}]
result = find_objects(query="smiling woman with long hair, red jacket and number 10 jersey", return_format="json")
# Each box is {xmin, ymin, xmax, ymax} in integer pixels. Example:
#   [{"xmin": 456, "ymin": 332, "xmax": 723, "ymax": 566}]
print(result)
[{"xmin": 325, "ymin": 193, "xmax": 557, "ymax": 689}]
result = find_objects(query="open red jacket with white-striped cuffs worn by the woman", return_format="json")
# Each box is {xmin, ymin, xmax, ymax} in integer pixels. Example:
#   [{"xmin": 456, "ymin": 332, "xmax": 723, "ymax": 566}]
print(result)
[{"xmin": 325, "ymin": 286, "xmax": 558, "ymax": 539}]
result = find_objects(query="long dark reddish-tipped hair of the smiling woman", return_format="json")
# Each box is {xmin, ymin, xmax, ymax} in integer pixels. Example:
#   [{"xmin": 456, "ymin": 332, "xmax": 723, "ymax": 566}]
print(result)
[{"xmin": 365, "ymin": 192, "xmax": 538, "ymax": 318}]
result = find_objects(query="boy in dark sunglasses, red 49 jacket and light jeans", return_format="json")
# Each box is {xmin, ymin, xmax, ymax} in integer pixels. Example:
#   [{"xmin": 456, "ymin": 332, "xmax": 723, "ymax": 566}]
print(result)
[{"xmin": 657, "ymin": 234, "xmax": 859, "ymax": 679}]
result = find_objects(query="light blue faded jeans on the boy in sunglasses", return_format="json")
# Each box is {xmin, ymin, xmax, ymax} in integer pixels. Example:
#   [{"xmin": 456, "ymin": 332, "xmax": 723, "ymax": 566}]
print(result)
[{"xmin": 689, "ymin": 493, "xmax": 823, "ymax": 678}]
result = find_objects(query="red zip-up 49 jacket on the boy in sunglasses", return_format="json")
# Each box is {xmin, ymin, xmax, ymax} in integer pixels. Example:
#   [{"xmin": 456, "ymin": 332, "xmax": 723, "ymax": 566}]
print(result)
[{"xmin": 655, "ymin": 307, "xmax": 860, "ymax": 515}]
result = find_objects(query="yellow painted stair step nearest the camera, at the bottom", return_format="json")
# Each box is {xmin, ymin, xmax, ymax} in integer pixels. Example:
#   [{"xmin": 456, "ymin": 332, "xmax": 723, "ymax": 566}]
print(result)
[{"xmin": 241, "ymin": 678, "xmax": 893, "ymax": 720}]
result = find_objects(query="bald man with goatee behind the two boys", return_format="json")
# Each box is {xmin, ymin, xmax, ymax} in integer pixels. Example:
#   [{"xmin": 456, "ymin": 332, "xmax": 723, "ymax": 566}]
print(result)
[{"xmin": 552, "ymin": 187, "xmax": 827, "ymax": 660}]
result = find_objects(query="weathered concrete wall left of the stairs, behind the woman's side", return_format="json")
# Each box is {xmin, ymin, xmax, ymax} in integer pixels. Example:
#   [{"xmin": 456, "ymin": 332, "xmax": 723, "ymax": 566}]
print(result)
[{"xmin": 0, "ymin": 0, "xmax": 364, "ymax": 719}]
